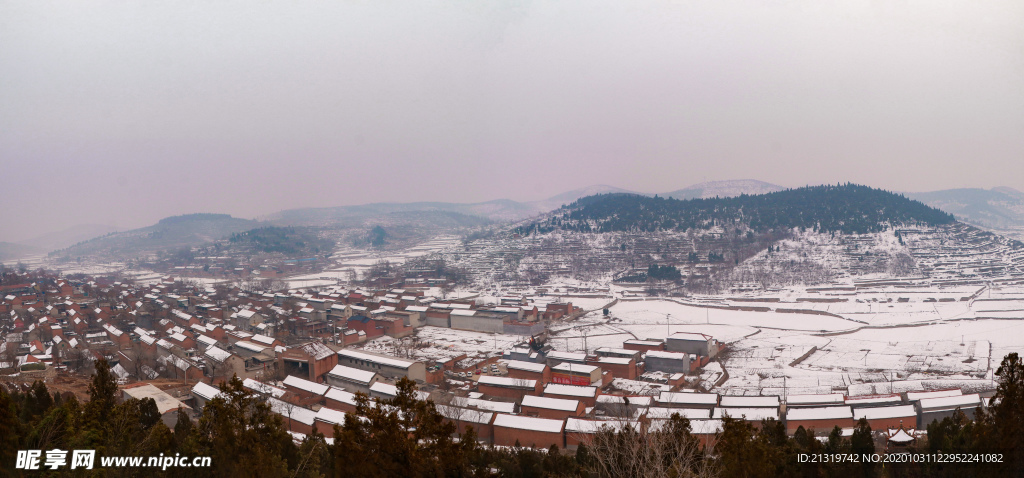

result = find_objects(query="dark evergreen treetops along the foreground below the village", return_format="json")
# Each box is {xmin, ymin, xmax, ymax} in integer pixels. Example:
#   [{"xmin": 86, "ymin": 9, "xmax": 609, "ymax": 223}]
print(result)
[{"xmin": 0, "ymin": 353, "xmax": 1024, "ymax": 478}]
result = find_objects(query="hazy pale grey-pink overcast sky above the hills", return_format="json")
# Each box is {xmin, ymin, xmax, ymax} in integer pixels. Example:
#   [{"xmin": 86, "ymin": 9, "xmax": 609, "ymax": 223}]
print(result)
[{"xmin": 0, "ymin": 0, "xmax": 1024, "ymax": 241}]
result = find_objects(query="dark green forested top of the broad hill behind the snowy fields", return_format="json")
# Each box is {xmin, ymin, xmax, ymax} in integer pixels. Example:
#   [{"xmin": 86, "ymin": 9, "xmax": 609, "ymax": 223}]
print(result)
[{"xmin": 515, "ymin": 183, "xmax": 955, "ymax": 235}]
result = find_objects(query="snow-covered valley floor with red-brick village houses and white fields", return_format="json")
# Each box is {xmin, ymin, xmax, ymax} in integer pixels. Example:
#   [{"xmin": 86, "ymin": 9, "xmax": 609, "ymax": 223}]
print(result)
[{"xmin": 0, "ymin": 254, "xmax": 1024, "ymax": 456}]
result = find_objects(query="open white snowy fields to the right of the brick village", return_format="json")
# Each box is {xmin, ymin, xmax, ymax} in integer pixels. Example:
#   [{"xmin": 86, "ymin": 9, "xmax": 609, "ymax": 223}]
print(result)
[{"xmin": 549, "ymin": 287, "xmax": 1024, "ymax": 395}]
